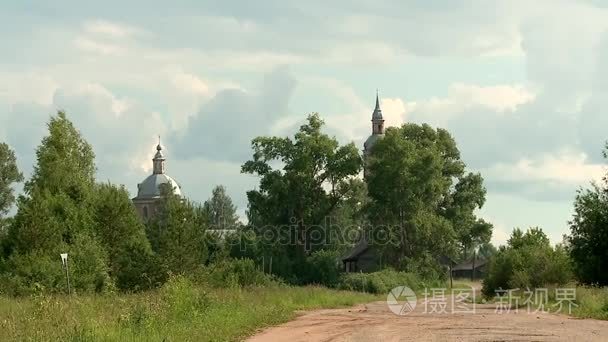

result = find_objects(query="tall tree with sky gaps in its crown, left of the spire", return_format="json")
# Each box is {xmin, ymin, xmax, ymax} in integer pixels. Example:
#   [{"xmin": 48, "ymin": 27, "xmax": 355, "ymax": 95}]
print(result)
[{"xmin": 241, "ymin": 113, "xmax": 362, "ymax": 277}]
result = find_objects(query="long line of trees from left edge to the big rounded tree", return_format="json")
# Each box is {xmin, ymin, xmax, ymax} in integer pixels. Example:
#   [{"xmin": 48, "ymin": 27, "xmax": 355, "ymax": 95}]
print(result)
[{"xmin": 0, "ymin": 112, "xmax": 492, "ymax": 294}]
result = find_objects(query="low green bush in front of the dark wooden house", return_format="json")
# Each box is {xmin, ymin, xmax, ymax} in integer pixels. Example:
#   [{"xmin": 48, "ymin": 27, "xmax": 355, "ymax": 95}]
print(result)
[{"xmin": 338, "ymin": 269, "xmax": 427, "ymax": 294}]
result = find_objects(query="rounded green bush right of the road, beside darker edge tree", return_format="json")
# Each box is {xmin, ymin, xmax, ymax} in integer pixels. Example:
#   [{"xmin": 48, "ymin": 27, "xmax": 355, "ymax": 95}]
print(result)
[{"xmin": 483, "ymin": 228, "xmax": 572, "ymax": 296}]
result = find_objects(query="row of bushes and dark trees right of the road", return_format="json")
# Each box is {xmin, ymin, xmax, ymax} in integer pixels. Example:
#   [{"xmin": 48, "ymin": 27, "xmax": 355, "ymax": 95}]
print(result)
[{"xmin": 483, "ymin": 145, "xmax": 608, "ymax": 296}]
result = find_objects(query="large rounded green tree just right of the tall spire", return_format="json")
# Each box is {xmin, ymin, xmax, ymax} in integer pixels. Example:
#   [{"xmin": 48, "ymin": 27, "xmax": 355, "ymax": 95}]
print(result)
[{"xmin": 366, "ymin": 124, "xmax": 491, "ymax": 266}]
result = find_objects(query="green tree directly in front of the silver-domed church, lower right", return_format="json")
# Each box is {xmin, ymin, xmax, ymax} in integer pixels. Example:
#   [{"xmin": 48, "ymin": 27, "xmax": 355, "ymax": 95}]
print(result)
[{"xmin": 146, "ymin": 187, "xmax": 208, "ymax": 274}]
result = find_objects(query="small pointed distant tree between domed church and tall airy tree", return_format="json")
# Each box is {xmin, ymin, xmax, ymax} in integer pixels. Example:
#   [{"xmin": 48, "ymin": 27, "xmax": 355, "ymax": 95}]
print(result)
[{"xmin": 203, "ymin": 185, "xmax": 239, "ymax": 230}]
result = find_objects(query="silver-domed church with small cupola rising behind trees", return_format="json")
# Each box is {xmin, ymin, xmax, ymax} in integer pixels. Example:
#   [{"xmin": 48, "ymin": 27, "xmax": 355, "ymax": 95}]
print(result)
[{"xmin": 132, "ymin": 138, "xmax": 182, "ymax": 221}]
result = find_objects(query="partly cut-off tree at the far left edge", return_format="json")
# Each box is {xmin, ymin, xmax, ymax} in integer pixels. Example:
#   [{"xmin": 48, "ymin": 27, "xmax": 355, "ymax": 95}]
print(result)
[{"xmin": 0, "ymin": 143, "xmax": 23, "ymax": 218}]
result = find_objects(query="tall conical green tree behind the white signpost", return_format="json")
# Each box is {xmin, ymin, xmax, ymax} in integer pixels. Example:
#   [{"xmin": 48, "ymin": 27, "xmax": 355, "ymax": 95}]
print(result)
[{"xmin": 6, "ymin": 112, "xmax": 111, "ymax": 291}]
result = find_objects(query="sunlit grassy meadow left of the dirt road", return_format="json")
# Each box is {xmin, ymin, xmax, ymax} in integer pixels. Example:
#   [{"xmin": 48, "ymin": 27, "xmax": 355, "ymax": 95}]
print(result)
[{"xmin": 0, "ymin": 278, "xmax": 379, "ymax": 341}]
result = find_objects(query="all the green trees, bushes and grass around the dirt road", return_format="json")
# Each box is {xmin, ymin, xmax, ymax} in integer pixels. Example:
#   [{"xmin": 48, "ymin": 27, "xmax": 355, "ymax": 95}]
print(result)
[{"xmin": 0, "ymin": 107, "xmax": 608, "ymax": 340}]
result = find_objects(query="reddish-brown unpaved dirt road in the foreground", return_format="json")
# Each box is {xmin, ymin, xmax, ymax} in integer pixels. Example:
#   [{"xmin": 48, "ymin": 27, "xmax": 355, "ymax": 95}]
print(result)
[{"xmin": 249, "ymin": 302, "xmax": 608, "ymax": 342}]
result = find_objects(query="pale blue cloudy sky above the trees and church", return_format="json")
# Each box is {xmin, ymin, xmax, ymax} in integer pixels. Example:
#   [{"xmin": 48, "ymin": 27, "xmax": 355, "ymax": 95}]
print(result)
[{"xmin": 0, "ymin": 0, "xmax": 608, "ymax": 244}]
